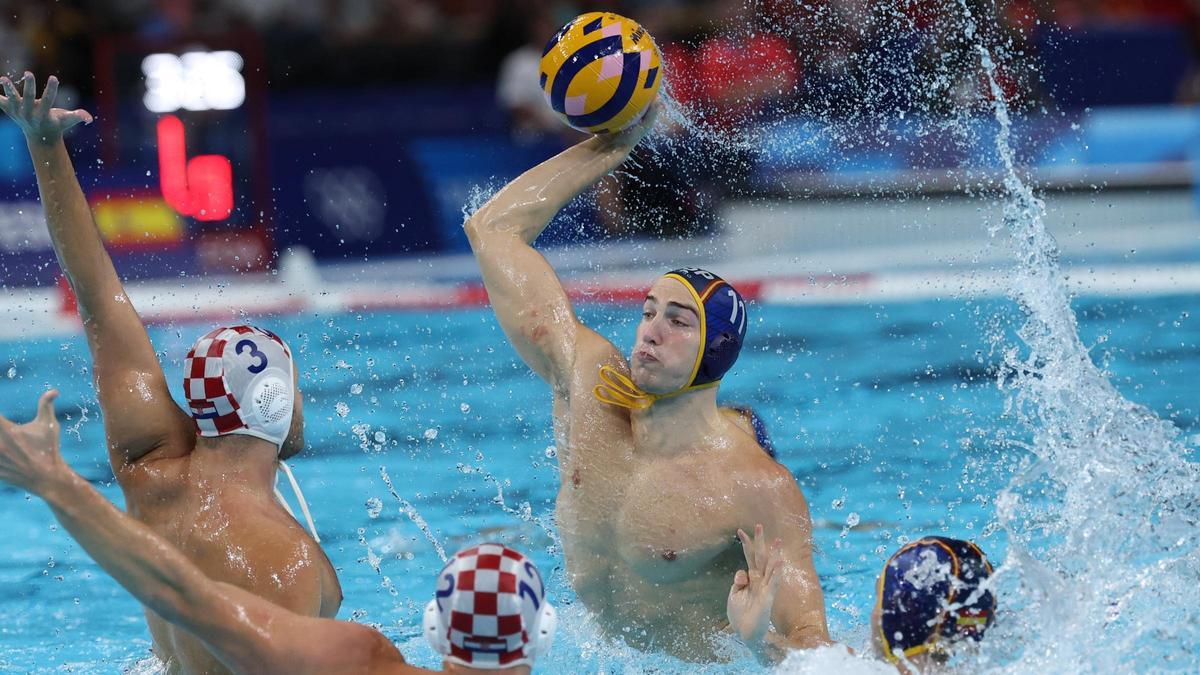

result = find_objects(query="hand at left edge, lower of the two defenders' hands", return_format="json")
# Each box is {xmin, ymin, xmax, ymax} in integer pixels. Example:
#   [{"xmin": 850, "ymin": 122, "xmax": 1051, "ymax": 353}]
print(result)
[{"xmin": 0, "ymin": 389, "xmax": 66, "ymax": 492}]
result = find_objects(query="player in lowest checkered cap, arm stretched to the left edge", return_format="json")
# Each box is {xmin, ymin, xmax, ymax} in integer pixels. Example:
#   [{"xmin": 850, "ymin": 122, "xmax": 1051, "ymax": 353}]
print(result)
[{"xmin": 0, "ymin": 392, "xmax": 557, "ymax": 675}]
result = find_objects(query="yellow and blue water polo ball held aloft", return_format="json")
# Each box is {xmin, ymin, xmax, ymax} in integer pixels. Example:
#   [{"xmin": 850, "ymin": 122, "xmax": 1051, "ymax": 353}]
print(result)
[{"xmin": 541, "ymin": 12, "xmax": 662, "ymax": 133}]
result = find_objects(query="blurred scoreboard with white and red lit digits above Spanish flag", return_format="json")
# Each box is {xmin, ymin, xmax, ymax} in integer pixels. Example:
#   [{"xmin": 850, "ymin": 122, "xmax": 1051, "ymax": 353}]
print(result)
[{"xmin": 85, "ymin": 34, "xmax": 274, "ymax": 274}]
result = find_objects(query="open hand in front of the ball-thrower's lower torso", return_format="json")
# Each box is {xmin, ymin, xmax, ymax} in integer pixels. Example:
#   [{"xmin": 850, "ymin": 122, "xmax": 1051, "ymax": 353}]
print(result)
[{"xmin": 725, "ymin": 525, "xmax": 784, "ymax": 647}]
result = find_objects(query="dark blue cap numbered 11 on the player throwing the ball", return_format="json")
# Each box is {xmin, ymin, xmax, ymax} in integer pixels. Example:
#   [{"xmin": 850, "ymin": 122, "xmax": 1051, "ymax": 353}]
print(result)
[{"xmin": 664, "ymin": 267, "xmax": 746, "ymax": 389}]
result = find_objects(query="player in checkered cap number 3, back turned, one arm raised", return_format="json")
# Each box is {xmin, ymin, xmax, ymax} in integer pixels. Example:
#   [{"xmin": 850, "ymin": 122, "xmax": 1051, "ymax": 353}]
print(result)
[{"xmin": 0, "ymin": 73, "xmax": 342, "ymax": 673}]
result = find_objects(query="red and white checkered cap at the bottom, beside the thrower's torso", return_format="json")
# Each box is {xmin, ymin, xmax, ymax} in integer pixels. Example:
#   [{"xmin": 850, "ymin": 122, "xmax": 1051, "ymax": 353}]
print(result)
[{"xmin": 425, "ymin": 544, "xmax": 558, "ymax": 669}]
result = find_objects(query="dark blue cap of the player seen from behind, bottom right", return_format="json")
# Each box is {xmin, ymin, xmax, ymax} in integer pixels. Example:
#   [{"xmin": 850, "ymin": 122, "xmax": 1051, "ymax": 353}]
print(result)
[{"xmin": 877, "ymin": 537, "xmax": 996, "ymax": 663}]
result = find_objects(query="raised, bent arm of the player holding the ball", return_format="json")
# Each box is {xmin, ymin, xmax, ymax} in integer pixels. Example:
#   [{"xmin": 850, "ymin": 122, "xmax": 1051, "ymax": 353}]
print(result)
[{"xmin": 464, "ymin": 103, "xmax": 658, "ymax": 390}]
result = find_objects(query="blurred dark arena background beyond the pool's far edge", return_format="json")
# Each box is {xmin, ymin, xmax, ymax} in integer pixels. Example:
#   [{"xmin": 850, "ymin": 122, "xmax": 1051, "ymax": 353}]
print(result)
[{"xmin": 0, "ymin": 0, "xmax": 1200, "ymax": 317}]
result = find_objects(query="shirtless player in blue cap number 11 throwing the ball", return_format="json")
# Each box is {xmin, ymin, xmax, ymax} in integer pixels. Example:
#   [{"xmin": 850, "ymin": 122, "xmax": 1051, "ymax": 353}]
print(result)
[{"xmin": 466, "ymin": 102, "xmax": 828, "ymax": 659}]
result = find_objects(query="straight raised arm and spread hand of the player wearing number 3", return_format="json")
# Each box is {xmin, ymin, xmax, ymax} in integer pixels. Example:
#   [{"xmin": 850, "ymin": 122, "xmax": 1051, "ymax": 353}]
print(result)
[{"xmin": 0, "ymin": 73, "xmax": 190, "ymax": 468}]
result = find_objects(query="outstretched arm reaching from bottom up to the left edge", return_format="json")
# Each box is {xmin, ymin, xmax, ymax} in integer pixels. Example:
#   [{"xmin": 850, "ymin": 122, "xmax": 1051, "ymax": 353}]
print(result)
[{"xmin": 0, "ymin": 390, "xmax": 421, "ymax": 674}]
